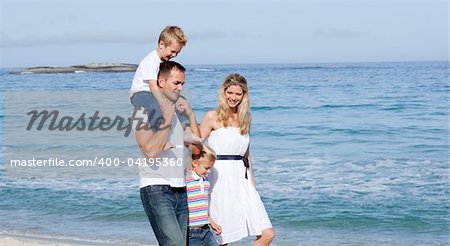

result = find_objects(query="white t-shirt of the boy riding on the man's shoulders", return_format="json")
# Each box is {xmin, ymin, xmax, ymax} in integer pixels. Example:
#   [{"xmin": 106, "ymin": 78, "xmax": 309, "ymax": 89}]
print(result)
[{"xmin": 129, "ymin": 50, "xmax": 162, "ymax": 97}]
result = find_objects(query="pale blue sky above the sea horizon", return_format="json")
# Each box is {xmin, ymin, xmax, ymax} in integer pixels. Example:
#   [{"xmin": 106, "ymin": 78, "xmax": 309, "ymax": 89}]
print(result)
[{"xmin": 0, "ymin": 0, "xmax": 449, "ymax": 67}]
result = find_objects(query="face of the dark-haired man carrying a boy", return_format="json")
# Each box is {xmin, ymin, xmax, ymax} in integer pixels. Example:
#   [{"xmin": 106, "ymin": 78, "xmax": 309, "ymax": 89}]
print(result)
[{"xmin": 159, "ymin": 69, "xmax": 185, "ymax": 102}]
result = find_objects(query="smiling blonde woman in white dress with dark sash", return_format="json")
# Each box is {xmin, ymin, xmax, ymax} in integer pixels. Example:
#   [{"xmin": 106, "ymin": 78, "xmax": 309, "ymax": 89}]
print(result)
[{"xmin": 200, "ymin": 74, "xmax": 275, "ymax": 245}]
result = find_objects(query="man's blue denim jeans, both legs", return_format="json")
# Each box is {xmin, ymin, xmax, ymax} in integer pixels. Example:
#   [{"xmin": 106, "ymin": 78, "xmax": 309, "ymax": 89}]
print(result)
[{"xmin": 140, "ymin": 185, "xmax": 188, "ymax": 246}]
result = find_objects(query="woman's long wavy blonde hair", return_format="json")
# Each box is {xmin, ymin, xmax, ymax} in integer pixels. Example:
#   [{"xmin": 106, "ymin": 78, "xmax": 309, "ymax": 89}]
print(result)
[{"xmin": 216, "ymin": 73, "xmax": 250, "ymax": 135}]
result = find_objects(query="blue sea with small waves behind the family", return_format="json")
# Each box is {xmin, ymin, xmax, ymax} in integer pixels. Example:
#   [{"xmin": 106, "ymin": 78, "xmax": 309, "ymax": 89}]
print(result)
[{"xmin": 0, "ymin": 61, "xmax": 450, "ymax": 246}]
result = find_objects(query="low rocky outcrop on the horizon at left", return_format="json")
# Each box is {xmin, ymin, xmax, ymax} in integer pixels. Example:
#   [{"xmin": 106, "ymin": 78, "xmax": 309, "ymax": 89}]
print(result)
[{"xmin": 11, "ymin": 63, "xmax": 137, "ymax": 74}]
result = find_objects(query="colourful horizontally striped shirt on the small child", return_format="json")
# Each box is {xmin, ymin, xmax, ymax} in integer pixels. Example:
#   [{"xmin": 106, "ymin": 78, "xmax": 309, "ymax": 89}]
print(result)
[{"xmin": 186, "ymin": 171, "xmax": 209, "ymax": 226}]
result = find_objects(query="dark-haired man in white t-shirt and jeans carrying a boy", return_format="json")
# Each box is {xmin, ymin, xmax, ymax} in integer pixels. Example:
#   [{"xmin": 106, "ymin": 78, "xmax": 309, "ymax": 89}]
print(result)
[{"xmin": 134, "ymin": 61, "xmax": 200, "ymax": 246}]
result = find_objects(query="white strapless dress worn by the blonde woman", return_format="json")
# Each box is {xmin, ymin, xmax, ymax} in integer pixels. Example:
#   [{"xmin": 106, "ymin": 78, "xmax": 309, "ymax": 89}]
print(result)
[{"xmin": 208, "ymin": 127, "xmax": 272, "ymax": 244}]
